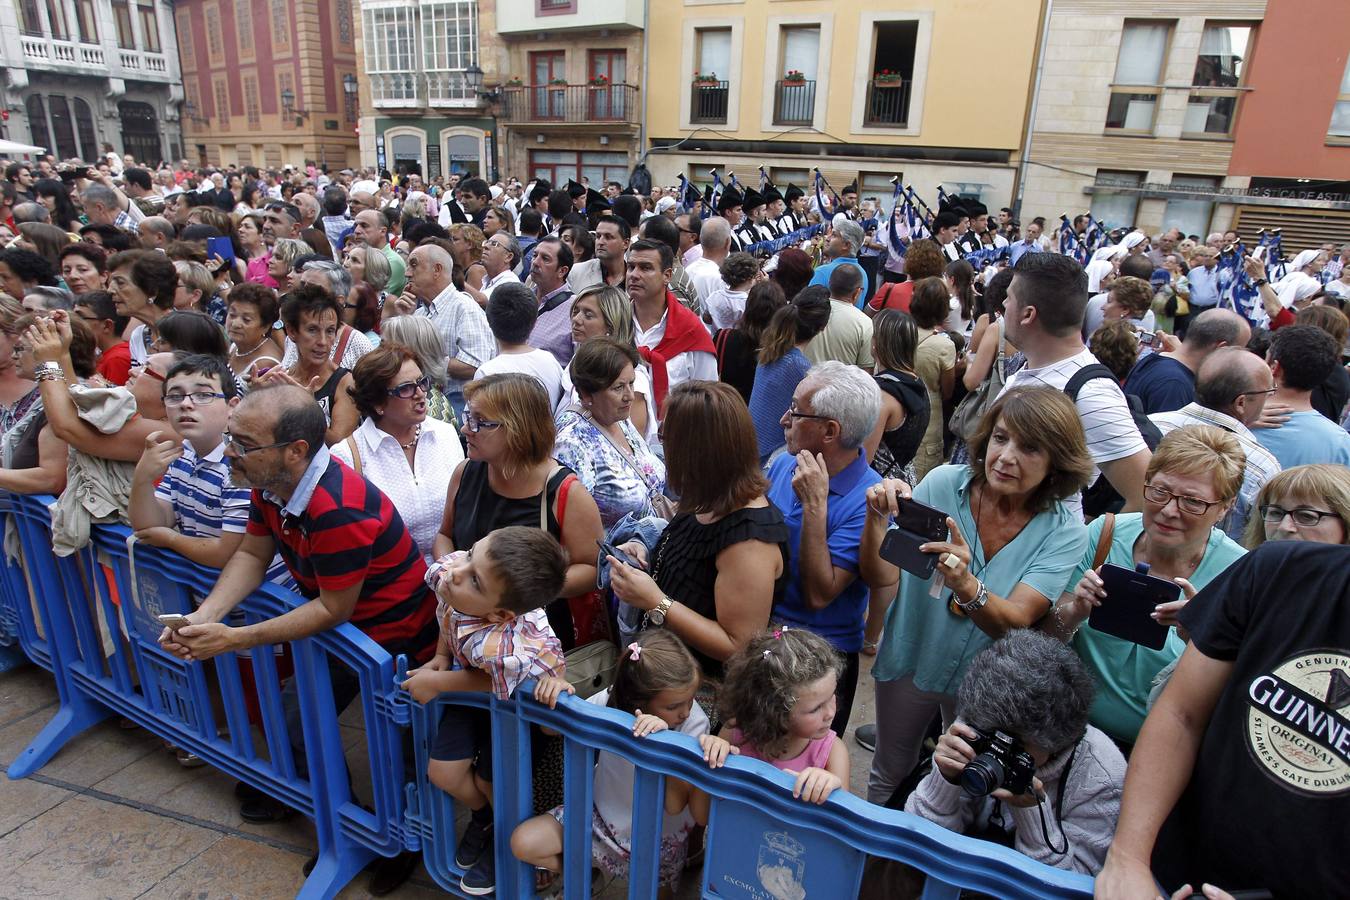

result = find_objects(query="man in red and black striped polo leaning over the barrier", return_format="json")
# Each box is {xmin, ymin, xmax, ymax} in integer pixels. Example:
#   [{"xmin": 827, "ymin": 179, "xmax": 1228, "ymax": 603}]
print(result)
[{"xmin": 161, "ymin": 385, "xmax": 437, "ymax": 822}]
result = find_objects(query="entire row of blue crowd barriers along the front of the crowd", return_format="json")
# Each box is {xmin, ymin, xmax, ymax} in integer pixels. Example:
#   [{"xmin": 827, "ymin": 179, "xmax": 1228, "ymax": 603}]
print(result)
[{"xmin": 0, "ymin": 497, "xmax": 1092, "ymax": 900}]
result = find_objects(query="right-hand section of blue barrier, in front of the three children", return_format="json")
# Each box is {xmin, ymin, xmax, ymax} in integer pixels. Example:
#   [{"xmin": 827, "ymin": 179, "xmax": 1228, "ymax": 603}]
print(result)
[{"xmin": 400, "ymin": 669, "xmax": 1092, "ymax": 900}]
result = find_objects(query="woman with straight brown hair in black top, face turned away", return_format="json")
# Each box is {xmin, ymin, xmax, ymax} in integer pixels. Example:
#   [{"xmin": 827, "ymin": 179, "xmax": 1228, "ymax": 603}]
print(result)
[{"xmin": 610, "ymin": 382, "xmax": 788, "ymax": 676}]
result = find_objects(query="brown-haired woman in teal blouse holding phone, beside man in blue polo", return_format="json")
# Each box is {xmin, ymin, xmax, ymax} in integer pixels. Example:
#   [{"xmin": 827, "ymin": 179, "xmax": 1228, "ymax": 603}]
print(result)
[{"xmin": 859, "ymin": 387, "xmax": 1092, "ymax": 803}]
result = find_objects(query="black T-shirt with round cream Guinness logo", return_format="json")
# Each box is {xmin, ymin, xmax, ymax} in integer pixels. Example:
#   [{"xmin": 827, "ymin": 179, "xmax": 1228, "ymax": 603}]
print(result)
[{"xmin": 1153, "ymin": 541, "xmax": 1350, "ymax": 897}]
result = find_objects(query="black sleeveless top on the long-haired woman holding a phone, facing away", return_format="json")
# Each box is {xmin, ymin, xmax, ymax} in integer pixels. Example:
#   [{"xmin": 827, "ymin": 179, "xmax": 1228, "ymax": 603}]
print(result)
[{"xmin": 652, "ymin": 503, "xmax": 788, "ymax": 677}]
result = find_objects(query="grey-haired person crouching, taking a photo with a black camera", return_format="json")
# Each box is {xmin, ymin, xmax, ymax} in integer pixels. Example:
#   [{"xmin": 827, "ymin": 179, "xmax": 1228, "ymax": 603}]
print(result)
[{"xmin": 905, "ymin": 630, "xmax": 1125, "ymax": 876}]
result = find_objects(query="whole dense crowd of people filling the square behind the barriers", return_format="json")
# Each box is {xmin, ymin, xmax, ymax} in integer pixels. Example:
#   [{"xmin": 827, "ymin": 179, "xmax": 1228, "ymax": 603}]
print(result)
[{"xmin": 0, "ymin": 157, "xmax": 1350, "ymax": 897}]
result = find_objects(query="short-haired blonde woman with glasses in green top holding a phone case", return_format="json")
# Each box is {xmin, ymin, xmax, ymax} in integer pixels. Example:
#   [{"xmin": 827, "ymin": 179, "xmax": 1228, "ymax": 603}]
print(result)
[{"xmin": 1046, "ymin": 425, "xmax": 1246, "ymax": 748}]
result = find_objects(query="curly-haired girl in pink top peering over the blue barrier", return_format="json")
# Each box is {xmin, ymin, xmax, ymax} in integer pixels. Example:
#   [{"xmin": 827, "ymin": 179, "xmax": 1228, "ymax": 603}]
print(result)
[{"xmin": 712, "ymin": 625, "xmax": 848, "ymax": 815}]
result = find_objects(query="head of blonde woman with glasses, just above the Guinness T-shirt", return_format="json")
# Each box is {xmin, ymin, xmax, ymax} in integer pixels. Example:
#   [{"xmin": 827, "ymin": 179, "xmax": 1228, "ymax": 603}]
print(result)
[{"xmin": 1243, "ymin": 463, "xmax": 1350, "ymax": 551}]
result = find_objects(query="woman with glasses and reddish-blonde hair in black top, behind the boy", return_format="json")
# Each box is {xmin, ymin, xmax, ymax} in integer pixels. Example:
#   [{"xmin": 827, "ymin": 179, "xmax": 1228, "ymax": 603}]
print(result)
[{"xmin": 435, "ymin": 372, "xmax": 605, "ymax": 650}]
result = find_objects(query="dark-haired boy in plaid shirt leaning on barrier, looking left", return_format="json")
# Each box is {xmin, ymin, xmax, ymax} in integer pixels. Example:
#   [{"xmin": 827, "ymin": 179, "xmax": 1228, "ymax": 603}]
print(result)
[{"xmin": 404, "ymin": 526, "xmax": 567, "ymax": 896}]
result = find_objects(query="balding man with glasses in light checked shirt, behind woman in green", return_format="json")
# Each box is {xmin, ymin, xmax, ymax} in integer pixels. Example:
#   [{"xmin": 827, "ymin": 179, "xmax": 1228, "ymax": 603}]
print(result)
[{"xmin": 1149, "ymin": 348, "xmax": 1280, "ymax": 541}]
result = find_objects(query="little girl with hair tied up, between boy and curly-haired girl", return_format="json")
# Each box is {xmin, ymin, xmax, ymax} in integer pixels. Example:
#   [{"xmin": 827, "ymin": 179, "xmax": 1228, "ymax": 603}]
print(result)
[{"xmin": 510, "ymin": 630, "xmax": 736, "ymax": 892}]
